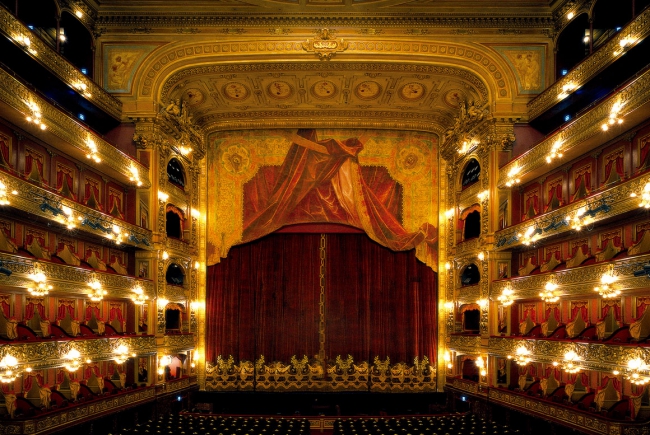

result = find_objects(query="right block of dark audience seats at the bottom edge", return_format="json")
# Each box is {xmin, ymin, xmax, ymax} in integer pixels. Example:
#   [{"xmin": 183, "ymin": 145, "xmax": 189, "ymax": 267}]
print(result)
[{"xmin": 333, "ymin": 415, "xmax": 520, "ymax": 435}]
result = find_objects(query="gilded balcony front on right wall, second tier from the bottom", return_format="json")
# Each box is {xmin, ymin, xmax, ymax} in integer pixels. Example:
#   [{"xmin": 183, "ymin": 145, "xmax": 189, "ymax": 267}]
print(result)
[{"xmin": 488, "ymin": 337, "xmax": 650, "ymax": 372}]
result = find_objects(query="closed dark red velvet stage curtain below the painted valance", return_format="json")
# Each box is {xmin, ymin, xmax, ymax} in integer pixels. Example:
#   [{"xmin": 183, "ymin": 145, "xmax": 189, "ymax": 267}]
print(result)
[{"xmin": 206, "ymin": 234, "xmax": 436, "ymax": 362}]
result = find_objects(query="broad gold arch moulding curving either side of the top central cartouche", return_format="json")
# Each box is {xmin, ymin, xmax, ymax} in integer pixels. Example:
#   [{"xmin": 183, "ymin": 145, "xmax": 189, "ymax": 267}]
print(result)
[{"xmin": 130, "ymin": 37, "xmax": 516, "ymax": 118}]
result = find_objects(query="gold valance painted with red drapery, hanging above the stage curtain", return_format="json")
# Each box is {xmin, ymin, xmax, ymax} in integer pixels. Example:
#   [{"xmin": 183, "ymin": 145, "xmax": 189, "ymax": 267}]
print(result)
[{"xmin": 208, "ymin": 129, "xmax": 438, "ymax": 270}]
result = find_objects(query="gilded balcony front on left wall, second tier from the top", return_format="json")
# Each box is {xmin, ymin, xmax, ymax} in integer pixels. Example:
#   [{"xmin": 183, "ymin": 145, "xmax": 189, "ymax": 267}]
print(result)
[{"xmin": 0, "ymin": 69, "xmax": 151, "ymax": 188}]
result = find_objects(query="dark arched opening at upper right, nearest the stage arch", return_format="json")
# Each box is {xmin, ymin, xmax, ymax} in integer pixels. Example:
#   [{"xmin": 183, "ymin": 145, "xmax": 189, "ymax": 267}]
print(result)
[{"xmin": 555, "ymin": 13, "xmax": 589, "ymax": 79}]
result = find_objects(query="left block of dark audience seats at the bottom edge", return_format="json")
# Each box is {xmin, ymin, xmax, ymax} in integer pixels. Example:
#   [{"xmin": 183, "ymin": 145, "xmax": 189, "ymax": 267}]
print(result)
[{"xmin": 117, "ymin": 414, "xmax": 310, "ymax": 435}]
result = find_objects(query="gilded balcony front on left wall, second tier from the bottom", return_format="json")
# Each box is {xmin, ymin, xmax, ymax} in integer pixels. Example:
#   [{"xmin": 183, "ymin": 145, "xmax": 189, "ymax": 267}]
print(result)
[{"xmin": 0, "ymin": 336, "xmax": 156, "ymax": 370}]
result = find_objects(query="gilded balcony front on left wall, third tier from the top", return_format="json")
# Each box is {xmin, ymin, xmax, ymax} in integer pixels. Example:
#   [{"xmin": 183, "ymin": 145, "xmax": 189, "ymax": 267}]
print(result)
[{"xmin": 0, "ymin": 174, "xmax": 152, "ymax": 249}]
